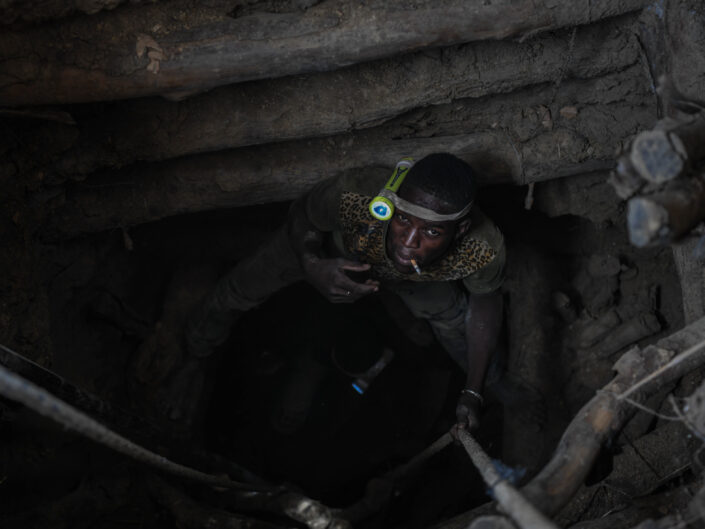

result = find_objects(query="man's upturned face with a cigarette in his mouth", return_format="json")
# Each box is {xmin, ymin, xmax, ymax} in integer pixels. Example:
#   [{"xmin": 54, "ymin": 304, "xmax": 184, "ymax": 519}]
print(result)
[{"xmin": 386, "ymin": 187, "xmax": 469, "ymax": 274}]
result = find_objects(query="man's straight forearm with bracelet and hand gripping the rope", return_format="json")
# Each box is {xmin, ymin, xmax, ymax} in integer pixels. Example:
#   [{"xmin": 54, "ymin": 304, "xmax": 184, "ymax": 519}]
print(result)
[{"xmin": 456, "ymin": 290, "xmax": 502, "ymax": 430}]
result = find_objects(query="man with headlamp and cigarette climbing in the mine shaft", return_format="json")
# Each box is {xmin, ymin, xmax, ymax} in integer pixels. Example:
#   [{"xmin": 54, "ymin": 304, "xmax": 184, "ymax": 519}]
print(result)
[{"xmin": 179, "ymin": 153, "xmax": 536, "ymax": 430}]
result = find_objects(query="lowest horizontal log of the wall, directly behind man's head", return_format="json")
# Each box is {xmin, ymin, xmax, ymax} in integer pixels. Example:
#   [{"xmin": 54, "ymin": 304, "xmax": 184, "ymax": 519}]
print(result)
[{"xmin": 42, "ymin": 132, "xmax": 612, "ymax": 240}]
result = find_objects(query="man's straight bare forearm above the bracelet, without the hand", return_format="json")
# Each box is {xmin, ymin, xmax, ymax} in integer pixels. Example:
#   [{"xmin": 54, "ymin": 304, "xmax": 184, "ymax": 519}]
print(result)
[{"xmin": 465, "ymin": 291, "xmax": 502, "ymax": 394}]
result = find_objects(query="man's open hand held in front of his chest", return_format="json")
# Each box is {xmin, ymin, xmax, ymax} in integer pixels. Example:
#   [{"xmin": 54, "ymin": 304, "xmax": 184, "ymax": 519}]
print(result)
[{"xmin": 303, "ymin": 257, "xmax": 379, "ymax": 303}]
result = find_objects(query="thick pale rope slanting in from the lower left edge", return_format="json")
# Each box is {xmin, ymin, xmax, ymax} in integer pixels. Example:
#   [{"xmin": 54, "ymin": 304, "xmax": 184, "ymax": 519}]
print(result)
[{"xmin": 0, "ymin": 360, "xmax": 278, "ymax": 492}]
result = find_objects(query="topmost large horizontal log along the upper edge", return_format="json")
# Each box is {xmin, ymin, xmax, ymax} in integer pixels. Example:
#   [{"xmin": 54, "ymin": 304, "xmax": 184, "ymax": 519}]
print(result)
[{"xmin": 0, "ymin": 0, "xmax": 649, "ymax": 106}]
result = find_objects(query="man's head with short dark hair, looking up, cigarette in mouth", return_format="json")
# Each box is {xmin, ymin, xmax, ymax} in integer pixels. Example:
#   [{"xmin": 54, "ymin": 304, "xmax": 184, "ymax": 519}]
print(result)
[{"xmin": 386, "ymin": 153, "xmax": 477, "ymax": 273}]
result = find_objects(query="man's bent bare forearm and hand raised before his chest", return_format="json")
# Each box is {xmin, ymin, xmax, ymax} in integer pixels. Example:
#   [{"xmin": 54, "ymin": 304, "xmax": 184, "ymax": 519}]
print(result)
[{"xmin": 287, "ymin": 198, "xmax": 379, "ymax": 303}]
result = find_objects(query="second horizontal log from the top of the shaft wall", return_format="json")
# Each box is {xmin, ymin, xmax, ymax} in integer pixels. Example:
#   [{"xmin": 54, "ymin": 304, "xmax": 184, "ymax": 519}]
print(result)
[{"xmin": 59, "ymin": 15, "xmax": 639, "ymax": 174}]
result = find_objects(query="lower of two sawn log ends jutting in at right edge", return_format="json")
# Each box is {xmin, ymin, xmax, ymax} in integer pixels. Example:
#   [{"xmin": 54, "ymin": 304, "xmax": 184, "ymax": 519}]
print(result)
[{"xmin": 627, "ymin": 175, "xmax": 705, "ymax": 248}]
